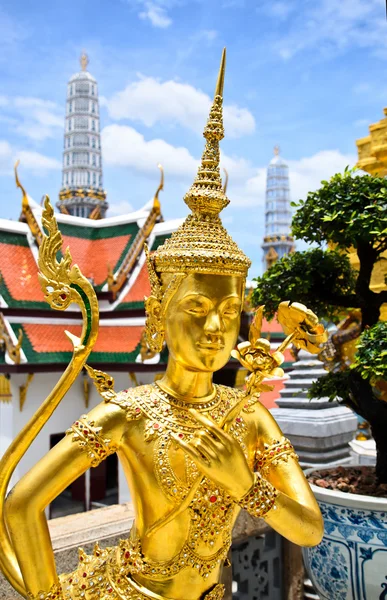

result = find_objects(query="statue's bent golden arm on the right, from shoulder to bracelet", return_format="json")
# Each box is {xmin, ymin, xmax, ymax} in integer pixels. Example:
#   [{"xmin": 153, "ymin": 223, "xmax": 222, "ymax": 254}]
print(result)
[{"xmin": 256, "ymin": 404, "xmax": 324, "ymax": 546}]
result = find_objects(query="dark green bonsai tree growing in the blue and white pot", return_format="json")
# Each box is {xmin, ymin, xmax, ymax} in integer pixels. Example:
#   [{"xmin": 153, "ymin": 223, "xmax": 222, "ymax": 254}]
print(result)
[{"xmin": 252, "ymin": 169, "xmax": 387, "ymax": 483}]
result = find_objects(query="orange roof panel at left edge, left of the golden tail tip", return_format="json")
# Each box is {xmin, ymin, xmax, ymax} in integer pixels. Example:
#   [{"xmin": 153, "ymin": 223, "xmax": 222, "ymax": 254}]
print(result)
[{"xmin": 0, "ymin": 242, "xmax": 44, "ymax": 308}]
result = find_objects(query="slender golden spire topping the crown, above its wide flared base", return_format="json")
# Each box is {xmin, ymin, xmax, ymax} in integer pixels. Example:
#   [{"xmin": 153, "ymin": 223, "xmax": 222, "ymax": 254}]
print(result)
[{"xmin": 184, "ymin": 48, "xmax": 230, "ymax": 216}]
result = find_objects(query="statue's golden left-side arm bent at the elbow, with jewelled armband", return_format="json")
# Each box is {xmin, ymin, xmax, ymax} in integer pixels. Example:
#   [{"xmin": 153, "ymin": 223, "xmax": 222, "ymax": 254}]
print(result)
[{"xmin": 5, "ymin": 403, "xmax": 127, "ymax": 597}]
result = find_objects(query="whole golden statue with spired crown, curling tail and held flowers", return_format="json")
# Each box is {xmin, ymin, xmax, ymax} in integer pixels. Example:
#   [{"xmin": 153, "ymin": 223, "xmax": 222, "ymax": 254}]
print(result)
[{"xmin": 0, "ymin": 54, "xmax": 326, "ymax": 600}]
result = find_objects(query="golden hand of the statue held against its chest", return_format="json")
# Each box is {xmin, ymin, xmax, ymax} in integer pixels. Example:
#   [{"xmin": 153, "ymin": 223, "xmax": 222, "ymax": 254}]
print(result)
[{"xmin": 173, "ymin": 409, "xmax": 254, "ymax": 500}]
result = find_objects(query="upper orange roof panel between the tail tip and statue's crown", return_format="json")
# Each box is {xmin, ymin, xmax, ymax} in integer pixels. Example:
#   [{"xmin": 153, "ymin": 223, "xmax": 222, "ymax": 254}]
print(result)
[{"xmin": 62, "ymin": 235, "xmax": 131, "ymax": 285}]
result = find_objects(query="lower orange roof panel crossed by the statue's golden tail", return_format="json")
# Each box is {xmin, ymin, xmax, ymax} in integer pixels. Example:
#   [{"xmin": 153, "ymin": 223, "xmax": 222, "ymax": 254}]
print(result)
[{"xmin": 23, "ymin": 323, "xmax": 144, "ymax": 353}]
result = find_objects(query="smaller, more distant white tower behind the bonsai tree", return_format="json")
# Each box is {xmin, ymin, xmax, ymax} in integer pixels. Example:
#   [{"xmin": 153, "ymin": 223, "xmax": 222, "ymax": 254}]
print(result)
[{"xmin": 262, "ymin": 146, "xmax": 294, "ymax": 269}]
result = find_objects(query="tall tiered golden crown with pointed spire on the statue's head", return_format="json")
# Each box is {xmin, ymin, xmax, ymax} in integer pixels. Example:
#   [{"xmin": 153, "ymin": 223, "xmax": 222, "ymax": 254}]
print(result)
[{"xmin": 151, "ymin": 49, "xmax": 251, "ymax": 277}]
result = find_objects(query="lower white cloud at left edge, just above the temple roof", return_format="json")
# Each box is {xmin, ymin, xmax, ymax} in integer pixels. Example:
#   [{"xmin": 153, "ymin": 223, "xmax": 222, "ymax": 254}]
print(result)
[{"xmin": 0, "ymin": 140, "xmax": 62, "ymax": 176}]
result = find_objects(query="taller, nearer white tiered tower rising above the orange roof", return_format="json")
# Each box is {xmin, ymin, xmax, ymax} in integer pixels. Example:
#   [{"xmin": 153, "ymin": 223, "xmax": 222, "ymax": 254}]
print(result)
[{"xmin": 57, "ymin": 54, "xmax": 108, "ymax": 219}]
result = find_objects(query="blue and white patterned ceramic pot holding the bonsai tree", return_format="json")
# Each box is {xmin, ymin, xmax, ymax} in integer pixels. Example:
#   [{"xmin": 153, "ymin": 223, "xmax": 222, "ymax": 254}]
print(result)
[{"xmin": 303, "ymin": 468, "xmax": 387, "ymax": 600}]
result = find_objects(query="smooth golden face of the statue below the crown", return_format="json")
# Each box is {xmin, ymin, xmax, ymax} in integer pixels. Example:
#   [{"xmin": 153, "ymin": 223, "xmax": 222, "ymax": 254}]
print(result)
[{"xmin": 165, "ymin": 274, "xmax": 244, "ymax": 372}]
